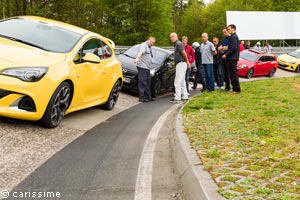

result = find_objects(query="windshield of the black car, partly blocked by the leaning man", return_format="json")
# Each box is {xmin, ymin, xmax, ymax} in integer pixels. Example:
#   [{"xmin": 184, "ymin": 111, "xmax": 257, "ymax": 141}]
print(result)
[{"xmin": 124, "ymin": 45, "xmax": 168, "ymax": 65}]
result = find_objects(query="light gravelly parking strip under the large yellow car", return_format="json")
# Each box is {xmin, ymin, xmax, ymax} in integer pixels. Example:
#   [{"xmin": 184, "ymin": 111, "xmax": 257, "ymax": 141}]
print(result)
[{"xmin": 0, "ymin": 93, "xmax": 138, "ymax": 191}]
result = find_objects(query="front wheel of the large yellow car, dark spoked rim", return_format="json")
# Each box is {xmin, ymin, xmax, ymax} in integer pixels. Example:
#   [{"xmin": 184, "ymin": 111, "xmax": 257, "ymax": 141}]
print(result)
[{"xmin": 40, "ymin": 81, "xmax": 72, "ymax": 128}]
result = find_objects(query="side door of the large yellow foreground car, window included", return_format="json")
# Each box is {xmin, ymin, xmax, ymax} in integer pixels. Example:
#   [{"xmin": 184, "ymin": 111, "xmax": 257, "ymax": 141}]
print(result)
[{"xmin": 74, "ymin": 38, "xmax": 107, "ymax": 104}]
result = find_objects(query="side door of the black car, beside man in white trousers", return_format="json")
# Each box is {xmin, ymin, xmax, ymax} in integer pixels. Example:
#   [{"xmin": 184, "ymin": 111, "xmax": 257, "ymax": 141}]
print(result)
[{"xmin": 163, "ymin": 53, "xmax": 176, "ymax": 88}]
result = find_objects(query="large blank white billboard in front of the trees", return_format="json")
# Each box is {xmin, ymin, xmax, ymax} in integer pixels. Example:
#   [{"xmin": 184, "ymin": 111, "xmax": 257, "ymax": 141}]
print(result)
[{"xmin": 226, "ymin": 11, "xmax": 300, "ymax": 40}]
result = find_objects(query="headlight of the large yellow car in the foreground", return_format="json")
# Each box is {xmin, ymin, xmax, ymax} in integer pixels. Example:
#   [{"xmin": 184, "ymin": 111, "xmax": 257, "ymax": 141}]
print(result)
[{"xmin": 0, "ymin": 67, "xmax": 48, "ymax": 82}]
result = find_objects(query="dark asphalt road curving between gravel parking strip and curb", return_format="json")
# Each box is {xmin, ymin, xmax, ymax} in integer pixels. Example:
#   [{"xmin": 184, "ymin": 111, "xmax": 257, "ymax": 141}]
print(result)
[{"xmin": 9, "ymin": 96, "xmax": 185, "ymax": 200}]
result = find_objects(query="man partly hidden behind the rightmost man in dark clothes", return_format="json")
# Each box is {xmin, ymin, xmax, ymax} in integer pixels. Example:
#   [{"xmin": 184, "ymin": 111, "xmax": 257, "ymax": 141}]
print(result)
[{"xmin": 219, "ymin": 26, "xmax": 230, "ymax": 92}]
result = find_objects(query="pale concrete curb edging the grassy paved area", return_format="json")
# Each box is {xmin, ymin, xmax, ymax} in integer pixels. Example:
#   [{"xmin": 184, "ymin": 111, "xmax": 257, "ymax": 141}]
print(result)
[{"xmin": 170, "ymin": 105, "xmax": 225, "ymax": 200}]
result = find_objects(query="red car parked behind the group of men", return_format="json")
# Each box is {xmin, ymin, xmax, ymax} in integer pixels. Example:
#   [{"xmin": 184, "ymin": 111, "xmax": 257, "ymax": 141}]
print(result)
[{"xmin": 237, "ymin": 50, "xmax": 278, "ymax": 78}]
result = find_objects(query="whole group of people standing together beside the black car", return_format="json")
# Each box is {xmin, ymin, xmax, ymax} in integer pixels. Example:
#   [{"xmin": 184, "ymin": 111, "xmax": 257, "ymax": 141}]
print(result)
[{"xmin": 134, "ymin": 24, "xmax": 241, "ymax": 103}]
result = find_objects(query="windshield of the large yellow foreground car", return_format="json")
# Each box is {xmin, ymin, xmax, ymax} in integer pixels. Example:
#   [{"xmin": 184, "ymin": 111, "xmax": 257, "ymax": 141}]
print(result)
[{"xmin": 0, "ymin": 18, "xmax": 82, "ymax": 53}]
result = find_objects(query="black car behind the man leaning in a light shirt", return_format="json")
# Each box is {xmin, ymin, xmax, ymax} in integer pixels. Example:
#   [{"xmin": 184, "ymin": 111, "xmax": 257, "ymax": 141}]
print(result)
[{"xmin": 117, "ymin": 45, "xmax": 175, "ymax": 97}]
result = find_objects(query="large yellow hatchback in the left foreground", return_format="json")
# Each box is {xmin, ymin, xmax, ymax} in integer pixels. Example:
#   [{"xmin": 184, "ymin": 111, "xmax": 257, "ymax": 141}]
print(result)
[{"xmin": 0, "ymin": 16, "xmax": 123, "ymax": 128}]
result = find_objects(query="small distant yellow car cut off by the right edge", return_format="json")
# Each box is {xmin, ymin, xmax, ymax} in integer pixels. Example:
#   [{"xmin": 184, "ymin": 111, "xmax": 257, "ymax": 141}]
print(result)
[{"xmin": 278, "ymin": 49, "xmax": 300, "ymax": 73}]
